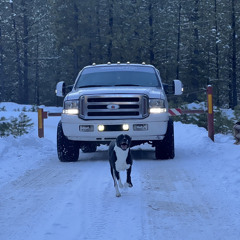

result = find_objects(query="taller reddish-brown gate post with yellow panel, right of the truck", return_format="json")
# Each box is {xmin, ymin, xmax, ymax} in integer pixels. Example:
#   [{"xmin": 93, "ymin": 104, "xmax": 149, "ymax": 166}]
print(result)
[{"xmin": 207, "ymin": 85, "xmax": 214, "ymax": 142}]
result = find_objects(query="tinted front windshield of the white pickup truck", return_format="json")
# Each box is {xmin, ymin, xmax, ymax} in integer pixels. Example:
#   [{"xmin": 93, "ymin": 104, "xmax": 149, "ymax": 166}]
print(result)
[{"xmin": 75, "ymin": 66, "xmax": 161, "ymax": 88}]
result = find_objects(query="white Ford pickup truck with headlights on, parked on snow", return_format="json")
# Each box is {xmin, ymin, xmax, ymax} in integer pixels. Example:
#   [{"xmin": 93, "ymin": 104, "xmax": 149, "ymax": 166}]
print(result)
[{"xmin": 56, "ymin": 63, "xmax": 182, "ymax": 162}]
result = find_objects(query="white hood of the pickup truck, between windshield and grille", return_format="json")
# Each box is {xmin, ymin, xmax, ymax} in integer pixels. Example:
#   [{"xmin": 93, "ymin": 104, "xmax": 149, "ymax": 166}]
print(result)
[{"xmin": 65, "ymin": 86, "xmax": 165, "ymax": 100}]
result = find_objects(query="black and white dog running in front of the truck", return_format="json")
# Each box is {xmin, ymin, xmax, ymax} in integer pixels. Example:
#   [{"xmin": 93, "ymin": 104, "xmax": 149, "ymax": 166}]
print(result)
[{"xmin": 109, "ymin": 134, "xmax": 133, "ymax": 197}]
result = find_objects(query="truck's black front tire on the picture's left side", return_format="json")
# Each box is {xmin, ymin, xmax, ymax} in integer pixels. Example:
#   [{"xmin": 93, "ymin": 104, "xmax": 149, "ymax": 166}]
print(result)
[{"xmin": 57, "ymin": 121, "xmax": 79, "ymax": 162}]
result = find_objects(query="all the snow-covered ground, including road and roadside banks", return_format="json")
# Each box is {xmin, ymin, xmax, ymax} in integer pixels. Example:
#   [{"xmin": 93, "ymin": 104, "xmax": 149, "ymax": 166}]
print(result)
[{"xmin": 0, "ymin": 103, "xmax": 240, "ymax": 240}]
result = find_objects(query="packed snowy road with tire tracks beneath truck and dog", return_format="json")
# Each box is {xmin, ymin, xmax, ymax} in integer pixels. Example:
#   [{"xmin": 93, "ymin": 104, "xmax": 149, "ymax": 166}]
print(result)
[{"xmin": 0, "ymin": 145, "xmax": 239, "ymax": 240}]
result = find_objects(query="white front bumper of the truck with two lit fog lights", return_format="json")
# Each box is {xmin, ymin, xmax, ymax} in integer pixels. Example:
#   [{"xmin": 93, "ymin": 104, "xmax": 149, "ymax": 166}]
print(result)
[{"xmin": 61, "ymin": 114, "xmax": 168, "ymax": 142}]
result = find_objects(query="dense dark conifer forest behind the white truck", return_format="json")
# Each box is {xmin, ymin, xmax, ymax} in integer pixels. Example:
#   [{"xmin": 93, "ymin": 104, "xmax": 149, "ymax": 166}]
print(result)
[{"xmin": 0, "ymin": 0, "xmax": 240, "ymax": 109}]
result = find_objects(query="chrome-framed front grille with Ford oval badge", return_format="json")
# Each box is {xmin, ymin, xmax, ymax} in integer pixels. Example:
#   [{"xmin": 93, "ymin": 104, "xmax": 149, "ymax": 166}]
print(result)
[{"xmin": 79, "ymin": 94, "xmax": 148, "ymax": 119}]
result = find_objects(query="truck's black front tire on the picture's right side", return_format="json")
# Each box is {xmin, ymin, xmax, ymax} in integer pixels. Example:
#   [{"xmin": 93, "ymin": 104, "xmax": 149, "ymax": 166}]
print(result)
[{"xmin": 155, "ymin": 119, "xmax": 175, "ymax": 159}]
